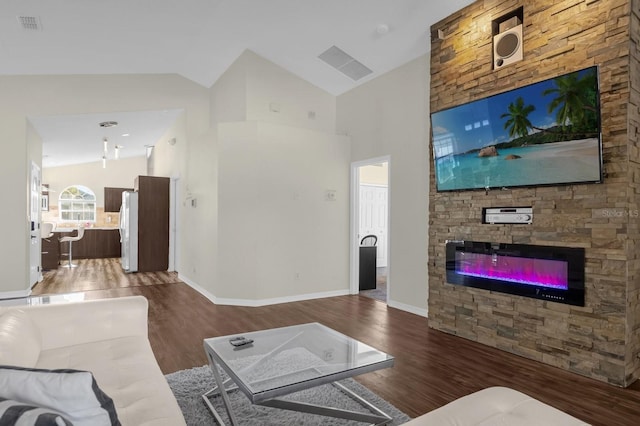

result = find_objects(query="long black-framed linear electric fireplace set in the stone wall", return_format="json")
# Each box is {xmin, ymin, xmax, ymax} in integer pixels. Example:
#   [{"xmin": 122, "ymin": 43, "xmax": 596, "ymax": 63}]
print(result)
[{"xmin": 446, "ymin": 241, "xmax": 584, "ymax": 306}]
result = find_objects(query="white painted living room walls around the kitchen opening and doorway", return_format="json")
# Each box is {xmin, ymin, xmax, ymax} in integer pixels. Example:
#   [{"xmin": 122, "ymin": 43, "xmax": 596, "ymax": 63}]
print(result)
[{"xmin": 0, "ymin": 52, "xmax": 429, "ymax": 310}]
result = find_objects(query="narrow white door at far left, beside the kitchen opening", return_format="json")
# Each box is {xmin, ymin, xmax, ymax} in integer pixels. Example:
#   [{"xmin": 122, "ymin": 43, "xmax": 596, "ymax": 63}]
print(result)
[{"xmin": 27, "ymin": 162, "xmax": 42, "ymax": 290}]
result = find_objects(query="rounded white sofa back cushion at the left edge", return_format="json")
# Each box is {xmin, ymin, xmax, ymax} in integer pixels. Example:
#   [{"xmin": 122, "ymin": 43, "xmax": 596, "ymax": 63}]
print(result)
[{"xmin": 0, "ymin": 309, "xmax": 42, "ymax": 367}]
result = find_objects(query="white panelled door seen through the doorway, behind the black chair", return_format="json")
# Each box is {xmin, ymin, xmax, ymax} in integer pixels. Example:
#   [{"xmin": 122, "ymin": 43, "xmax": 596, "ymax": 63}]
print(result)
[{"xmin": 359, "ymin": 184, "xmax": 388, "ymax": 267}]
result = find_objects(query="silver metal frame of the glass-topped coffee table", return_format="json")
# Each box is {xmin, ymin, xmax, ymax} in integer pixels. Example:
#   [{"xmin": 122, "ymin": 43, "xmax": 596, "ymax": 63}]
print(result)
[{"xmin": 202, "ymin": 323, "xmax": 394, "ymax": 426}]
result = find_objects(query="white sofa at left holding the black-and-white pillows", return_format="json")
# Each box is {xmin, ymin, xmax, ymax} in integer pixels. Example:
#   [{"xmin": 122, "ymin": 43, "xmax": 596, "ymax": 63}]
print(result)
[{"xmin": 0, "ymin": 296, "xmax": 185, "ymax": 426}]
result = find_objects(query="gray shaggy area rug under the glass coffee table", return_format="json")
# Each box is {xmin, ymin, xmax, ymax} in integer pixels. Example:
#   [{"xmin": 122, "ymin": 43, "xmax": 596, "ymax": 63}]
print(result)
[{"xmin": 165, "ymin": 365, "xmax": 410, "ymax": 426}]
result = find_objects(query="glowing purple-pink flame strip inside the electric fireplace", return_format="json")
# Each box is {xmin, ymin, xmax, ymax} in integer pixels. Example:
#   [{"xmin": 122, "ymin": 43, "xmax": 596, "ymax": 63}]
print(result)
[{"xmin": 455, "ymin": 252, "xmax": 569, "ymax": 290}]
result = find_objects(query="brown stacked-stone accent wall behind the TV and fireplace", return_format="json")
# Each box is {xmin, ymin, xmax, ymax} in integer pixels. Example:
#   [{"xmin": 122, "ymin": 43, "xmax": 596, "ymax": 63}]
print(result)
[{"xmin": 429, "ymin": 0, "xmax": 640, "ymax": 386}]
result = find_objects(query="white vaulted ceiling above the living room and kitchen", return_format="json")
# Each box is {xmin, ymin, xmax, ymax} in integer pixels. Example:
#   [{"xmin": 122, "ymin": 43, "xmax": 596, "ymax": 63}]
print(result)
[{"xmin": 0, "ymin": 0, "xmax": 473, "ymax": 167}]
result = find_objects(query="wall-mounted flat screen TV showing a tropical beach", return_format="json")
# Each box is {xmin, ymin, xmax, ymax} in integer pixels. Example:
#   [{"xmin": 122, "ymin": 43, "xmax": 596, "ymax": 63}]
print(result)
[{"xmin": 431, "ymin": 66, "xmax": 602, "ymax": 191}]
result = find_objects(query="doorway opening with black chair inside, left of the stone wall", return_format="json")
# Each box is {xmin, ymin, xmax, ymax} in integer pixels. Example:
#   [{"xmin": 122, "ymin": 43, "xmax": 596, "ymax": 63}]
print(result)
[{"xmin": 350, "ymin": 156, "xmax": 391, "ymax": 303}]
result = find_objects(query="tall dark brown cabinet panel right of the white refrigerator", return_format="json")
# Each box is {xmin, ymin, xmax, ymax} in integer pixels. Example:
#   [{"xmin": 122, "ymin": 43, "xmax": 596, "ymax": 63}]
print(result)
[{"xmin": 134, "ymin": 176, "xmax": 169, "ymax": 272}]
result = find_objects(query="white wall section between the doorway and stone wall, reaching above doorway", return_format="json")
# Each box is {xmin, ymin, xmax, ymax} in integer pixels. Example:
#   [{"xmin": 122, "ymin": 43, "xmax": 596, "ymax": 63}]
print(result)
[{"xmin": 337, "ymin": 56, "xmax": 430, "ymax": 315}]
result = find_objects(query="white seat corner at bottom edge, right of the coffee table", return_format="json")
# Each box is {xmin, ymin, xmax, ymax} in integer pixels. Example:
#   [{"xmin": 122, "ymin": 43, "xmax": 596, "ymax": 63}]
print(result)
[{"xmin": 405, "ymin": 386, "xmax": 589, "ymax": 426}]
